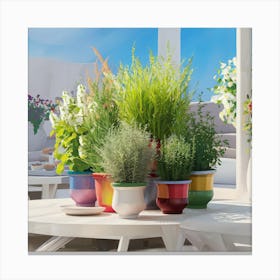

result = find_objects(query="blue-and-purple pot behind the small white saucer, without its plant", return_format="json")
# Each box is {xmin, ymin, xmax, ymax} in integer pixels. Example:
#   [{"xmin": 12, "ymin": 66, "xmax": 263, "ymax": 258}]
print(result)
[{"xmin": 68, "ymin": 171, "xmax": 96, "ymax": 207}]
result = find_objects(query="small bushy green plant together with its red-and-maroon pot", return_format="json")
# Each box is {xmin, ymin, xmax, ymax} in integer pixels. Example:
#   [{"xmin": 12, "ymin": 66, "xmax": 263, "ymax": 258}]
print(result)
[{"xmin": 157, "ymin": 135, "xmax": 194, "ymax": 214}]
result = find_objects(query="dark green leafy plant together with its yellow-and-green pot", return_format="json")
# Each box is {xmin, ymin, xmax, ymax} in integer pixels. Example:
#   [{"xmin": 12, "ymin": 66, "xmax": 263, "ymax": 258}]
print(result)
[{"xmin": 187, "ymin": 100, "xmax": 228, "ymax": 208}]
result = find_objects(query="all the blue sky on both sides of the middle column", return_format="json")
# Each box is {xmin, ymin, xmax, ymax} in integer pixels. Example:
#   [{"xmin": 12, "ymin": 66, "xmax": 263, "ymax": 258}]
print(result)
[{"xmin": 28, "ymin": 28, "xmax": 236, "ymax": 100}]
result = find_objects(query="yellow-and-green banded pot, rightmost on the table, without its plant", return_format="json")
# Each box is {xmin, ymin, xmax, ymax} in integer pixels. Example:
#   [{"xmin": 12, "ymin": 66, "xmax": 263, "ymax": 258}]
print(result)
[{"xmin": 187, "ymin": 170, "xmax": 215, "ymax": 209}]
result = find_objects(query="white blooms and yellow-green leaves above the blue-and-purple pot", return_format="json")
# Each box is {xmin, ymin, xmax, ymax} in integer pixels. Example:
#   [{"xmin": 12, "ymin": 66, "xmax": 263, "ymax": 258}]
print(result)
[{"xmin": 50, "ymin": 84, "xmax": 96, "ymax": 174}]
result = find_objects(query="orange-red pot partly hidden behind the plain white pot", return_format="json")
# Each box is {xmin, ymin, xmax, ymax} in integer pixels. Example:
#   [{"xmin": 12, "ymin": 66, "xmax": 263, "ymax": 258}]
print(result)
[{"xmin": 92, "ymin": 173, "xmax": 115, "ymax": 212}]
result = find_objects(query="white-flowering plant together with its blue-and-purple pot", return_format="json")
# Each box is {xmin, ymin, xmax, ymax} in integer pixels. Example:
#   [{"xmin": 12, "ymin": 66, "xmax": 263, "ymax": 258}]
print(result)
[{"xmin": 50, "ymin": 84, "xmax": 96, "ymax": 206}]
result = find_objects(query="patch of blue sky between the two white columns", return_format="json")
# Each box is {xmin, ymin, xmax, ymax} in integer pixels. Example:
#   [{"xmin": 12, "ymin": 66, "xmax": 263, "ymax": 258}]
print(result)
[{"xmin": 181, "ymin": 28, "xmax": 236, "ymax": 100}]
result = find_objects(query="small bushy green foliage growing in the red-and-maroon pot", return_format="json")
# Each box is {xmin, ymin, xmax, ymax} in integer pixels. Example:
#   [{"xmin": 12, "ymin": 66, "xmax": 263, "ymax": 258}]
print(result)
[{"xmin": 157, "ymin": 135, "xmax": 195, "ymax": 181}]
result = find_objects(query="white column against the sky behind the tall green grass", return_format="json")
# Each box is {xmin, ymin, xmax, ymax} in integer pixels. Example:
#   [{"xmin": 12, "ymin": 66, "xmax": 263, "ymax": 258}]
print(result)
[{"xmin": 158, "ymin": 28, "xmax": 181, "ymax": 65}]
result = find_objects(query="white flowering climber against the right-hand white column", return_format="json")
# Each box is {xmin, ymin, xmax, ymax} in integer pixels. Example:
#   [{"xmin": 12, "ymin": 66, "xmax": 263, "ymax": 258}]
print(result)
[{"xmin": 211, "ymin": 57, "xmax": 236, "ymax": 127}]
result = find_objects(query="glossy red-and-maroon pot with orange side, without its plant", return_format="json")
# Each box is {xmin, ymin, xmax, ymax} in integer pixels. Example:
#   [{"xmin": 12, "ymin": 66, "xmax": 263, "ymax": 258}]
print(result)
[{"xmin": 156, "ymin": 180, "xmax": 191, "ymax": 214}]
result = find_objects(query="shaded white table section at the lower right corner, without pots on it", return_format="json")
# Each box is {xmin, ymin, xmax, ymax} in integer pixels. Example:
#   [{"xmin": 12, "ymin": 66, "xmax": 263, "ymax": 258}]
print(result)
[{"xmin": 178, "ymin": 201, "xmax": 252, "ymax": 252}]
